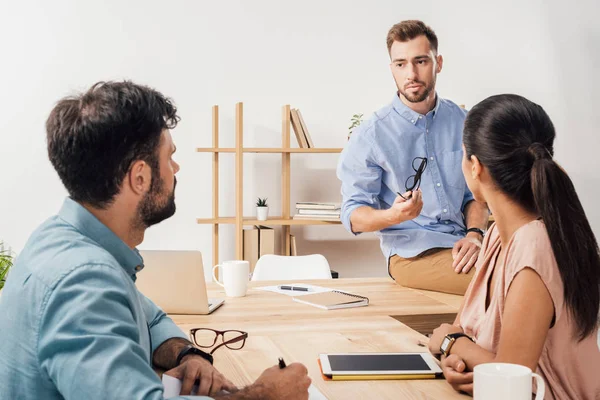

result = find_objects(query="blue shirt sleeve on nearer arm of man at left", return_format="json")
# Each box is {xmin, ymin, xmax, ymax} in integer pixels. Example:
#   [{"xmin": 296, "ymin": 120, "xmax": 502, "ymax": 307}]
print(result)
[{"xmin": 37, "ymin": 265, "xmax": 208, "ymax": 400}]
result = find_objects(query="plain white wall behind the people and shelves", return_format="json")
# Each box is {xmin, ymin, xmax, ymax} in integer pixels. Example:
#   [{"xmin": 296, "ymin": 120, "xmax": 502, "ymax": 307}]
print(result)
[{"xmin": 0, "ymin": 0, "xmax": 600, "ymax": 282}]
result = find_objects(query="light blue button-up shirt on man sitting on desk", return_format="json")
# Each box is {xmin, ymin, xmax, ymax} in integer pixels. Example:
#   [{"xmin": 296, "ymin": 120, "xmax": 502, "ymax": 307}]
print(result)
[{"xmin": 337, "ymin": 95, "xmax": 473, "ymax": 258}]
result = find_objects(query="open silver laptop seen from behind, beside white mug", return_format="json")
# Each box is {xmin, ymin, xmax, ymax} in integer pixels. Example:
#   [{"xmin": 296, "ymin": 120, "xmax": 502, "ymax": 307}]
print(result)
[{"xmin": 135, "ymin": 250, "xmax": 224, "ymax": 314}]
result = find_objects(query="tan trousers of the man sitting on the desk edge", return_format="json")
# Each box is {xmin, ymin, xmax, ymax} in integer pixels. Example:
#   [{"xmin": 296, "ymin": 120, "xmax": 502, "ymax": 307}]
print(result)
[{"xmin": 388, "ymin": 248, "xmax": 475, "ymax": 295}]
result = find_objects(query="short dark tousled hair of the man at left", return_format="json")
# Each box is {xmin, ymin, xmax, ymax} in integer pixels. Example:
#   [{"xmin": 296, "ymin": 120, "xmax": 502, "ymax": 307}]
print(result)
[{"xmin": 46, "ymin": 81, "xmax": 179, "ymax": 208}]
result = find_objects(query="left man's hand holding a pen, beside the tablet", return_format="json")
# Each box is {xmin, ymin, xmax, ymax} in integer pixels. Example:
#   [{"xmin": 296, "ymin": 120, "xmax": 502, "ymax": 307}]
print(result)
[{"xmin": 249, "ymin": 363, "xmax": 311, "ymax": 400}]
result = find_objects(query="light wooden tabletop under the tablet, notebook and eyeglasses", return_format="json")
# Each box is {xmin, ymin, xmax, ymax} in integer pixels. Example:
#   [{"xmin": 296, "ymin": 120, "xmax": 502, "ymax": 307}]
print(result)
[{"xmin": 171, "ymin": 278, "xmax": 468, "ymax": 400}]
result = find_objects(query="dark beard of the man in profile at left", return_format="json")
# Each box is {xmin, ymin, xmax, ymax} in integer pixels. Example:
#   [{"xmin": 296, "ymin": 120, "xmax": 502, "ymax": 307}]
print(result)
[{"xmin": 137, "ymin": 176, "xmax": 177, "ymax": 228}]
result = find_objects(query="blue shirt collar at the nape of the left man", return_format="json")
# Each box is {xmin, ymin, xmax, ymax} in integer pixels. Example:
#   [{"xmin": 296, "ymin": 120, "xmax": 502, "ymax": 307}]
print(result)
[{"xmin": 58, "ymin": 197, "xmax": 144, "ymax": 279}]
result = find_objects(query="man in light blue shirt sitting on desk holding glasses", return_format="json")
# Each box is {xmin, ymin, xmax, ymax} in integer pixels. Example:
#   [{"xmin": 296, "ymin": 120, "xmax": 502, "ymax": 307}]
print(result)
[{"xmin": 338, "ymin": 21, "xmax": 488, "ymax": 294}]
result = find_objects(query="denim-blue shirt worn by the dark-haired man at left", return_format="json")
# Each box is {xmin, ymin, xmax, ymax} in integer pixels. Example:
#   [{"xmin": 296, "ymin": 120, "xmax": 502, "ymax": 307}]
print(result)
[{"xmin": 0, "ymin": 199, "xmax": 207, "ymax": 400}]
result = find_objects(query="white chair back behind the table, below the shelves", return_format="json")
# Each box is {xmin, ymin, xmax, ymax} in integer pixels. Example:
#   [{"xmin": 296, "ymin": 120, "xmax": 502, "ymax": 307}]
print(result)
[{"xmin": 252, "ymin": 254, "xmax": 331, "ymax": 281}]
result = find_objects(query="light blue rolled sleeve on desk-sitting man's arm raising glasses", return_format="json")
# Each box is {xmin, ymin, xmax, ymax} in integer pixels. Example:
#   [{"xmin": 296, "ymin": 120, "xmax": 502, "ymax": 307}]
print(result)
[{"xmin": 337, "ymin": 126, "xmax": 383, "ymax": 235}]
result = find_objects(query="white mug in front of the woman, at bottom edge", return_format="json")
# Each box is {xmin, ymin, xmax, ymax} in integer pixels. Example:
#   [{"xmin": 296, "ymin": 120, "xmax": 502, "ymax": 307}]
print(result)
[{"xmin": 473, "ymin": 363, "xmax": 546, "ymax": 400}]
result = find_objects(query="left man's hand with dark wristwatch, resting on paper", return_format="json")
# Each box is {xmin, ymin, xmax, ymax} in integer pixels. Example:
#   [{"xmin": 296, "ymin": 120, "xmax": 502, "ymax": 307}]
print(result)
[{"xmin": 165, "ymin": 355, "xmax": 238, "ymax": 396}]
